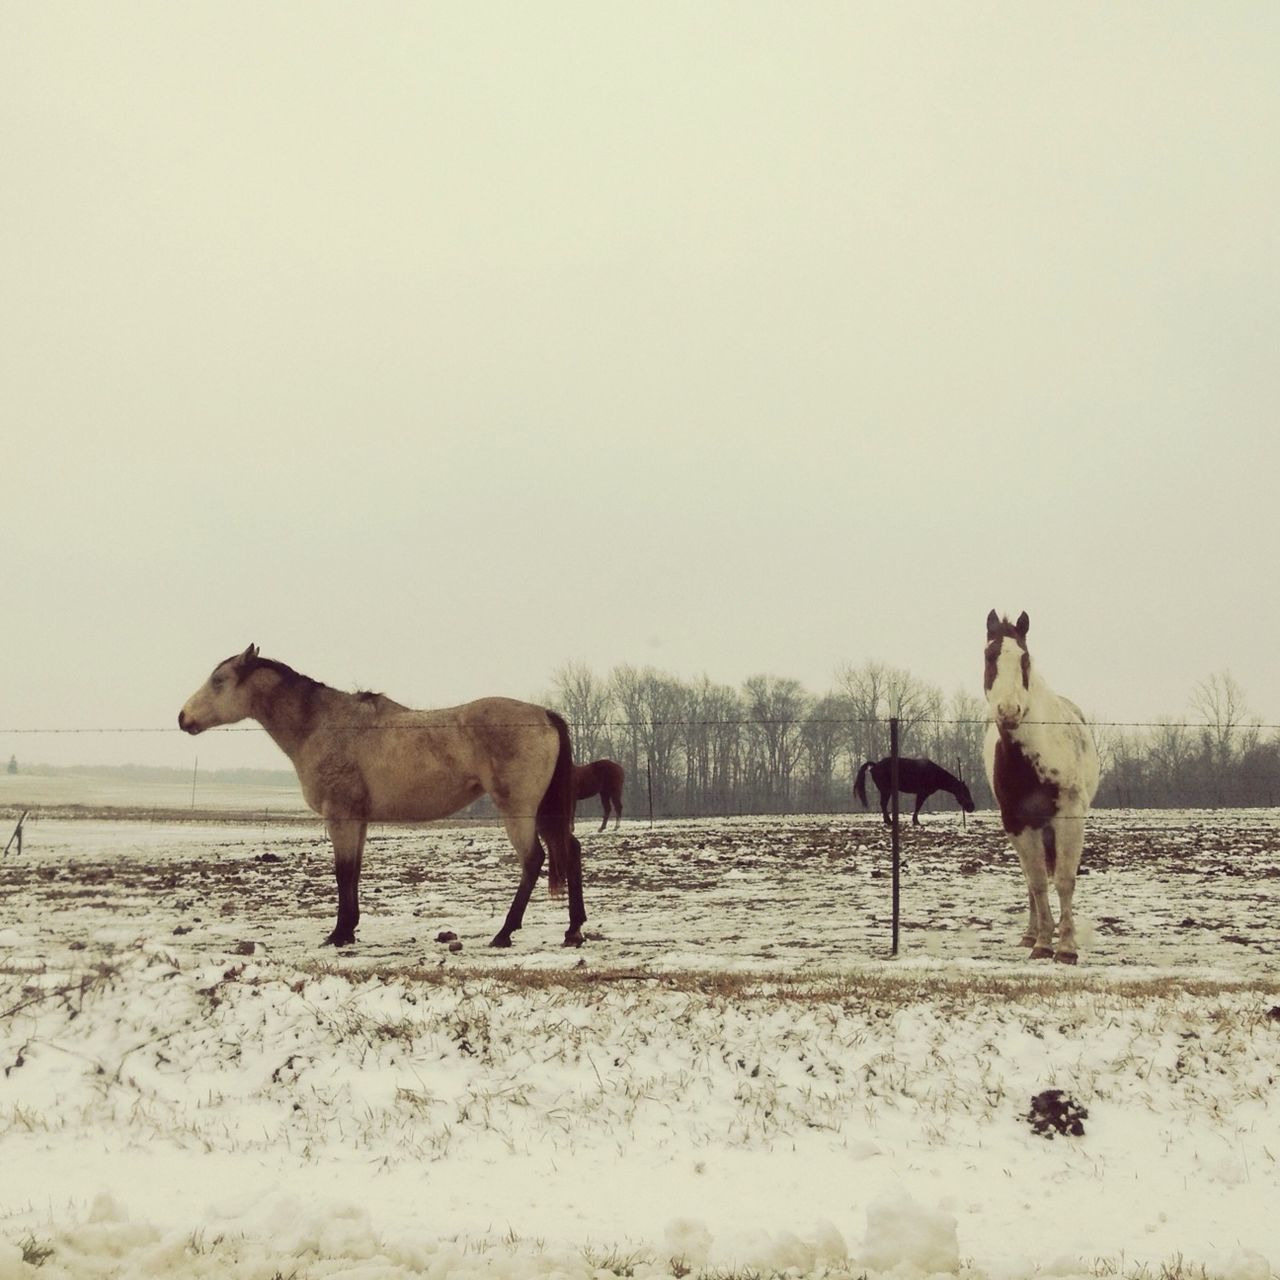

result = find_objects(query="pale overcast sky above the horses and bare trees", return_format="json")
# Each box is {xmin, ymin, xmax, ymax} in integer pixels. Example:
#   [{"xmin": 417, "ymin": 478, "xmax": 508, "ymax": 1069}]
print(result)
[{"xmin": 0, "ymin": 0, "xmax": 1280, "ymax": 767}]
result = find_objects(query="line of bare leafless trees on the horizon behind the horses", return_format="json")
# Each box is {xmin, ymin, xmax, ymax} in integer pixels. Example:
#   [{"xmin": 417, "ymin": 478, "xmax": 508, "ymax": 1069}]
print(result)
[{"xmin": 545, "ymin": 662, "xmax": 1280, "ymax": 817}]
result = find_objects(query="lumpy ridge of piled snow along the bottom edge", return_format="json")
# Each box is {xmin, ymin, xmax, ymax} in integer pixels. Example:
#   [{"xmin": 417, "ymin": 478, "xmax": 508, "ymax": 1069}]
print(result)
[{"xmin": 0, "ymin": 1192, "xmax": 1271, "ymax": 1280}]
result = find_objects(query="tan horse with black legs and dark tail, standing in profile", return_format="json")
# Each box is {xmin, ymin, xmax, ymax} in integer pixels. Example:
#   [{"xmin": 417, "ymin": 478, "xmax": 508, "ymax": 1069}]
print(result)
[{"xmin": 178, "ymin": 645, "xmax": 586, "ymax": 947}]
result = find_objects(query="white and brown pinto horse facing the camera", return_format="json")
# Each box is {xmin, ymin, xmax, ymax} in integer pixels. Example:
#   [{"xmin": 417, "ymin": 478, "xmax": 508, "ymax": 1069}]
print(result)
[{"xmin": 983, "ymin": 609, "xmax": 1098, "ymax": 964}]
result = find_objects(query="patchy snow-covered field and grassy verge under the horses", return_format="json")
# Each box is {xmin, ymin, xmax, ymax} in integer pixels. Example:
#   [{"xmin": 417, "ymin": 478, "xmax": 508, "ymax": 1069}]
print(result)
[{"xmin": 0, "ymin": 804, "xmax": 1280, "ymax": 1280}]
